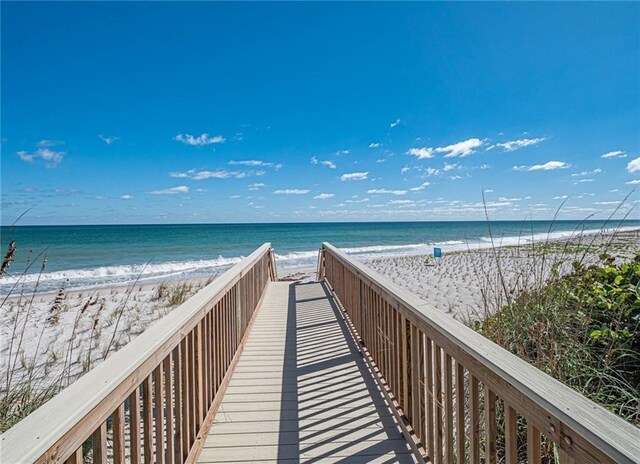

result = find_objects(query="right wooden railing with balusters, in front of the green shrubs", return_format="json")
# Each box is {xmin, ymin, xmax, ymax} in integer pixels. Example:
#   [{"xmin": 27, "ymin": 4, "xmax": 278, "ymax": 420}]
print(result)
[{"xmin": 318, "ymin": 243, "xmax": 640, "ymax": 464}]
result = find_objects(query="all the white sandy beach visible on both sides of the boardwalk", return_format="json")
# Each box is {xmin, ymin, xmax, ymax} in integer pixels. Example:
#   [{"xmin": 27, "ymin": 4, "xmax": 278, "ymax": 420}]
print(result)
[{"xmin": 0, "ymin": 230, "xmax": 640, "ymax": 398}]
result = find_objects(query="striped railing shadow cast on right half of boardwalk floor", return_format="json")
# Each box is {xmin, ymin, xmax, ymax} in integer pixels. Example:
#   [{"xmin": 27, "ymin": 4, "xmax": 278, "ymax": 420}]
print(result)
[{"xmin": 288, "ymin": 283, "xmax": 414, "ymax": 463}]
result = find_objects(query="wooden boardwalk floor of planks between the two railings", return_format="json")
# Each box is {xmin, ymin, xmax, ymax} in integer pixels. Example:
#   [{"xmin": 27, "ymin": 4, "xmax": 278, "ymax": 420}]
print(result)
[{"xmin": 198, "ymin": 282, "xmax": 415, "ymax": 463}]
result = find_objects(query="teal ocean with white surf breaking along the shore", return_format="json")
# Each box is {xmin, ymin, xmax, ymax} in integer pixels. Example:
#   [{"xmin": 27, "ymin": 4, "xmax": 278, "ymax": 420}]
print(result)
[{"xmin": 0, "ymin": 220, "xmax": 640, "ymax": 294}]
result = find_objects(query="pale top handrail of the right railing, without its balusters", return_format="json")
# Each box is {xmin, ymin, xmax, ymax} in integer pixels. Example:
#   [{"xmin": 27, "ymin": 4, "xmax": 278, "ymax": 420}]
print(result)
[{"xmin": 322, "ymin": 243, "xmax": 640, "ymax": 463}]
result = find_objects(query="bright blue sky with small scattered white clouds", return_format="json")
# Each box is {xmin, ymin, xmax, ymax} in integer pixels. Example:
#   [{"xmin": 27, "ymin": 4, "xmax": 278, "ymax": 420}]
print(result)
[{"xmin": 1, "ymin": 2, "xmax": 640, "ymax": 224}]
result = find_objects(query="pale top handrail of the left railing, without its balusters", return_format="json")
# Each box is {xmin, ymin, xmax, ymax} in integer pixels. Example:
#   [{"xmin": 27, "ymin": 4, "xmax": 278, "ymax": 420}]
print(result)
[{"xmin": 0, "ymin": 244, "xmax": 274, "ymax": 462}]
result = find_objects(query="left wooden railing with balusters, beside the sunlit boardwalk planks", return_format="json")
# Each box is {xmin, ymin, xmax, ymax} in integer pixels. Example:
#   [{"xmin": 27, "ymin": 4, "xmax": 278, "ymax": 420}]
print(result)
[{"xmin": 0, "ymin": 243, "xmax": 275, "ymax": 464}]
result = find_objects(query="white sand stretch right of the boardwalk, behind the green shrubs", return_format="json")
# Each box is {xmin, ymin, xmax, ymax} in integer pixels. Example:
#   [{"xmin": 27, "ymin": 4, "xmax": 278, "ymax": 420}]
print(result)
[{"xmin": 366, "ymin": 230, "xmax": 640, "ymax": 322}]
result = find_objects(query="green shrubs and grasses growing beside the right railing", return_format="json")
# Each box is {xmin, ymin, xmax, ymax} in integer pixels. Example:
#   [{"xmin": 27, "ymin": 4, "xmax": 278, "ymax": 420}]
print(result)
[{"xmin": 476, "ymin": 253, "xmax": 640, "ymax": 426}]
